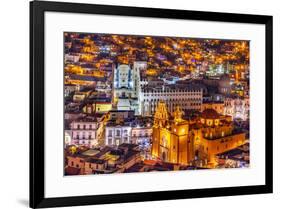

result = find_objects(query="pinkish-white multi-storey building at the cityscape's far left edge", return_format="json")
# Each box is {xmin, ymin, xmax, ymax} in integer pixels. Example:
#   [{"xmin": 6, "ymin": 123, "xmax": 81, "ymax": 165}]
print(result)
[{"xmin": 70, "ymin": 118, "xmax": 98, "ymax": 147}]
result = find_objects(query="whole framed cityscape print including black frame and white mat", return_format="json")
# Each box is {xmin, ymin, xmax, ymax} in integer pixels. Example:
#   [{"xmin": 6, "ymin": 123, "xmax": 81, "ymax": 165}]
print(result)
[{"xmin": 30, "ymin": 1, "xmax": 273, "ymax": 208}]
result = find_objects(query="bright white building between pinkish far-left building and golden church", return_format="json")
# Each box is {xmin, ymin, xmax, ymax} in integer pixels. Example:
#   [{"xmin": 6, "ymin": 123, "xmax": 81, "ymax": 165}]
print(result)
[{"xmin": 105, "ymin": 123, "xmax": 132, "ymax": 146}]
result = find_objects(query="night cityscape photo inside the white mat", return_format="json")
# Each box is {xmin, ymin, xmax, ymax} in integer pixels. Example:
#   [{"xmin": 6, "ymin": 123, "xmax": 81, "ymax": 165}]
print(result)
[{"xmin": 64, "ymin": 32, "xmax": 250, "ymax": 175}]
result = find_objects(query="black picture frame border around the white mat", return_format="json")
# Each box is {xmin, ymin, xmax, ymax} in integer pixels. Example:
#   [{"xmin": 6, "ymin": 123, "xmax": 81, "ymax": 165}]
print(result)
[{"xmin": 30, "ymin": 1, "xmax": 273, "ymax": 208}]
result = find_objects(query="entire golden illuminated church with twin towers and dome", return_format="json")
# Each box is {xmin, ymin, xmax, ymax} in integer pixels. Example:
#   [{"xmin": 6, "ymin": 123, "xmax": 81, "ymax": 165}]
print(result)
[{"xmin": 152, "ymin": 101, "xmax": 246, "ymax": 167}]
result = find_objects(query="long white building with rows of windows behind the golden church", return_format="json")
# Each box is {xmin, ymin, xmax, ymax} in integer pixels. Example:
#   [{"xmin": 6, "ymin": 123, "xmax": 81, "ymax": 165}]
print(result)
[{"xmin": 140, "ymin": 84, "xmax": 203, "ymax": 115}]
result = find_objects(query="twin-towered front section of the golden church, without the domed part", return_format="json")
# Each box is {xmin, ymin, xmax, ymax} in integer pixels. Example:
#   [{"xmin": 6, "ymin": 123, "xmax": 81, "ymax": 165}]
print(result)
[{"xmin": 152, "ymin": 101, "xmax": 194, "ymax": 165}]
